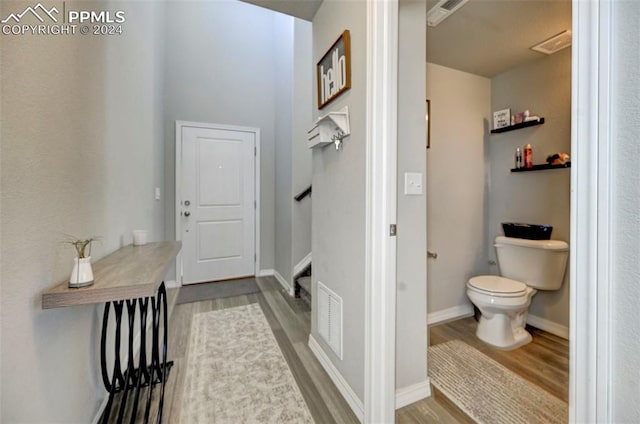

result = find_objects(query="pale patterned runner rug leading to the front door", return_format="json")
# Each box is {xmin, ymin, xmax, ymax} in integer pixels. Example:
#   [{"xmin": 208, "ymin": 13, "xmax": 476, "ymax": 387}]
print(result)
[{"xmin": 180, "ymin": 303, "xmax": 313, "ymax": 424}]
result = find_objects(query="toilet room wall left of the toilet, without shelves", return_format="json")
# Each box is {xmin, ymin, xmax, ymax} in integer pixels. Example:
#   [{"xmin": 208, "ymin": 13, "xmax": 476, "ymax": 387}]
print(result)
[{"xmin": 427, "ymin": 63, "xmax": 491, "ymax": 316}]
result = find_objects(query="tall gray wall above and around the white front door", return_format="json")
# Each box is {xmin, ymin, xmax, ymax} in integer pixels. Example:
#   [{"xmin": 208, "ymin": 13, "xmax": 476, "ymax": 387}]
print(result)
[{"xmin": 164, "ymin": 1, "xmax": 277, "ymax": 269}]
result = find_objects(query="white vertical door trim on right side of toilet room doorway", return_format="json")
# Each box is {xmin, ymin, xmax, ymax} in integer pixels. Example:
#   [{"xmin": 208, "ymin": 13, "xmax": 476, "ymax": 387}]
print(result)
[{"xmin": 569, "ymin": 0, "xmax": 613, "ymax": 423}]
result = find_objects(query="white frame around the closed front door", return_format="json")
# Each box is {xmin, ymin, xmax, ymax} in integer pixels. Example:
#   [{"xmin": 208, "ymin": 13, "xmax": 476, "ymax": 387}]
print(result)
[{"xmin": 174, "ymin": 120, "xmax": 260, "ymax": 286}]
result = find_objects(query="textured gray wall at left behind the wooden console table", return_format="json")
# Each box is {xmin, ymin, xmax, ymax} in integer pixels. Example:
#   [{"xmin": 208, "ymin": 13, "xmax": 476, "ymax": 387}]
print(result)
[{"xmin": 0, "ymin": 2, "xmax": 164, "ymax": 423}]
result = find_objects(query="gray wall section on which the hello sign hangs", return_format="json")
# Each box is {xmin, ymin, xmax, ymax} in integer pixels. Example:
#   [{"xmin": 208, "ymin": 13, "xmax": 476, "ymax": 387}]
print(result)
[{"xmin": 311, "ymin": 0, "xmax": 366, "ymax": 399}]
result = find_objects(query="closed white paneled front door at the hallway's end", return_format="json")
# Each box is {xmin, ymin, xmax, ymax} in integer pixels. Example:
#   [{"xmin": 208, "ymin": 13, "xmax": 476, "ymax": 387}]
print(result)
[{"xmin": 176, "ymin": 124, "xmax": 257, "ymax": 284}]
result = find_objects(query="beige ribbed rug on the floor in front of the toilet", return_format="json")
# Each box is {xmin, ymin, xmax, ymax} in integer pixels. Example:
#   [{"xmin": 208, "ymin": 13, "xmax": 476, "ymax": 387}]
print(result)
[{"xmin": 429, "ymin": 340, "xmax": 568, "ymax": 424}]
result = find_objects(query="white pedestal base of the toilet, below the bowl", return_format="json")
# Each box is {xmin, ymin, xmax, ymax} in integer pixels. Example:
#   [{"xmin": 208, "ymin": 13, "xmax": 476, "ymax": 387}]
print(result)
[{"xmin": 476, "ymin": 314, "xmax": 531, "ymax": 350}]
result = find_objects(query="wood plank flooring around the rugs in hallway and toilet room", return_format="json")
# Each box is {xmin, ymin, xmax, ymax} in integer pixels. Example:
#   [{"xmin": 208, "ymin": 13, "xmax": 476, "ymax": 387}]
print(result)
[{"xmin": 158, "ymin": 277, "xmax": 569, "ymax": 424}]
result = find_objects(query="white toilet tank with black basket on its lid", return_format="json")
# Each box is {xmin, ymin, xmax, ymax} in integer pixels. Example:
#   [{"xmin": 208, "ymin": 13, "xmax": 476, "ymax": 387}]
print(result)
[{"xmin": 494, "ymin": 236, "xmax": 569, "ymax": 290}]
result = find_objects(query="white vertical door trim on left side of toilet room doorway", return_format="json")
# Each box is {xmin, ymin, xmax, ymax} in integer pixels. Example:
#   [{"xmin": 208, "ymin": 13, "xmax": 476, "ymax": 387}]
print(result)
[{"xmin": 364, "ymin": 0, "xmax": 398, "ymax": 423}]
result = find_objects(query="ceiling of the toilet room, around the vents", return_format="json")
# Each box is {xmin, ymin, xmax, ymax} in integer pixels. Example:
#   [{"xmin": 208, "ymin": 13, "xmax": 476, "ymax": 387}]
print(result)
[{"xmin": 427, "ymin": 0, "xmax": 571, "ymax": 77}]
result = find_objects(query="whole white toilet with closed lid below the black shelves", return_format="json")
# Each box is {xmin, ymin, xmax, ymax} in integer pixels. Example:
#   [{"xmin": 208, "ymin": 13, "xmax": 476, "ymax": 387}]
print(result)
[{"xmin": 467, "ymin": 236, "xmax": 569, "ymax": 350}]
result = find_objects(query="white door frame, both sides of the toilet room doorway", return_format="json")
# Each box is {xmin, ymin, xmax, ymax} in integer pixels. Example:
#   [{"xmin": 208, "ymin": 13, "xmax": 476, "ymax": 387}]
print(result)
[{"xmin": 364, "ymin": 0, "xmax": 613, "ymax": 423}]
